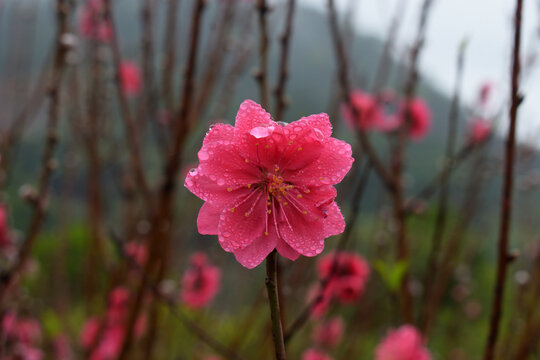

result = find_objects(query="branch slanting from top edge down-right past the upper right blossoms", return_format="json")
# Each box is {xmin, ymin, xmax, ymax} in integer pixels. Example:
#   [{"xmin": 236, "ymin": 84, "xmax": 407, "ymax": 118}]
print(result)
[{"xmin": 328, "ymin": 0, "xmax": 394, "ymax": 190}]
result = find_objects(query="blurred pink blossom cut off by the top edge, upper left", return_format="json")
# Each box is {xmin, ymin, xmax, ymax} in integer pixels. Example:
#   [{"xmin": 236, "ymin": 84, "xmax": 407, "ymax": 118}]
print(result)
[{"xmin": 79, "ymin": 0, "xmax": 113, "ymax": 43}]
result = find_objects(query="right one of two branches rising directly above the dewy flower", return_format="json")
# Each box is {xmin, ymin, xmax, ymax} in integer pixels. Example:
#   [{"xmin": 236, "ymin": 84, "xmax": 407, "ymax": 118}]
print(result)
[{"xmin": 274, "ymin": 0, "xmax": 296, "ymax": 121}]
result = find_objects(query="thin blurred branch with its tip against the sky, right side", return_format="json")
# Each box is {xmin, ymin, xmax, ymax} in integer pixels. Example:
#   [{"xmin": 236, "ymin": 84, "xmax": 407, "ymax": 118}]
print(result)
[{"xmin": 420, "ymin": 44, "xmax": 465, "ymax": 334}]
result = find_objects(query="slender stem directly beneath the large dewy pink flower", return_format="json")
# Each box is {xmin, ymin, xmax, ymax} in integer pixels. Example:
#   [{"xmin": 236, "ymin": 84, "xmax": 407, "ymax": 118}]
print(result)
[{"xmin": 266, "ymin": 250, "xmax": 287, "ymax": 360}]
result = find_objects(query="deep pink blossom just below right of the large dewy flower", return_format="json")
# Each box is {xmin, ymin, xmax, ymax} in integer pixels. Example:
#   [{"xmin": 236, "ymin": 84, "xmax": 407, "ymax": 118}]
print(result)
[{"xmin": 318, "ymin": 252, "xmax": 370, "ymax": 303}]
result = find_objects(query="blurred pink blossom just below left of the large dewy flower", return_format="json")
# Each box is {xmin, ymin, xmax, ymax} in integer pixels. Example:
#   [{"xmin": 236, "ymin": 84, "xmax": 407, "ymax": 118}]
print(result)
[{"xmin": 180, "ymin": 253, "xmax": 221, "ymax": 309}]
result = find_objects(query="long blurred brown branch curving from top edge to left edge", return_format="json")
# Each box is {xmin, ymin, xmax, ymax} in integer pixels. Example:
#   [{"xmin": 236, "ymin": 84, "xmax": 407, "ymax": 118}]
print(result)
[{"xmin": 0, "ymin": 0, "xmax": 70, "ymax": 308}]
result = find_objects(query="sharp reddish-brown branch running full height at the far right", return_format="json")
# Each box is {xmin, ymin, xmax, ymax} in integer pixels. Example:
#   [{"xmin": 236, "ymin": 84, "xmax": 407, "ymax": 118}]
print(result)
[{"xmin": 484, "ymin": 0, "xmax": 523, "ymax": 360}]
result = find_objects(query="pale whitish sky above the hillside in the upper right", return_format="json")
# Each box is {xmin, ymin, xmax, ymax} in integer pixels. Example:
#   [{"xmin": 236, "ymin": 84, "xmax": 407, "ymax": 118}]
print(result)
[{"xmin": 301, "ymin": 0, "xmax": 540, "ymax": 146}]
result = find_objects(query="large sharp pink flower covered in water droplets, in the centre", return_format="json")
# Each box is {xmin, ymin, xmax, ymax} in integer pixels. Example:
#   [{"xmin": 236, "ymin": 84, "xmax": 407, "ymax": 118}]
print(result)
[{"xmin": 185, "ymin": 100, "xmax": 353, "ymax": 269}]
